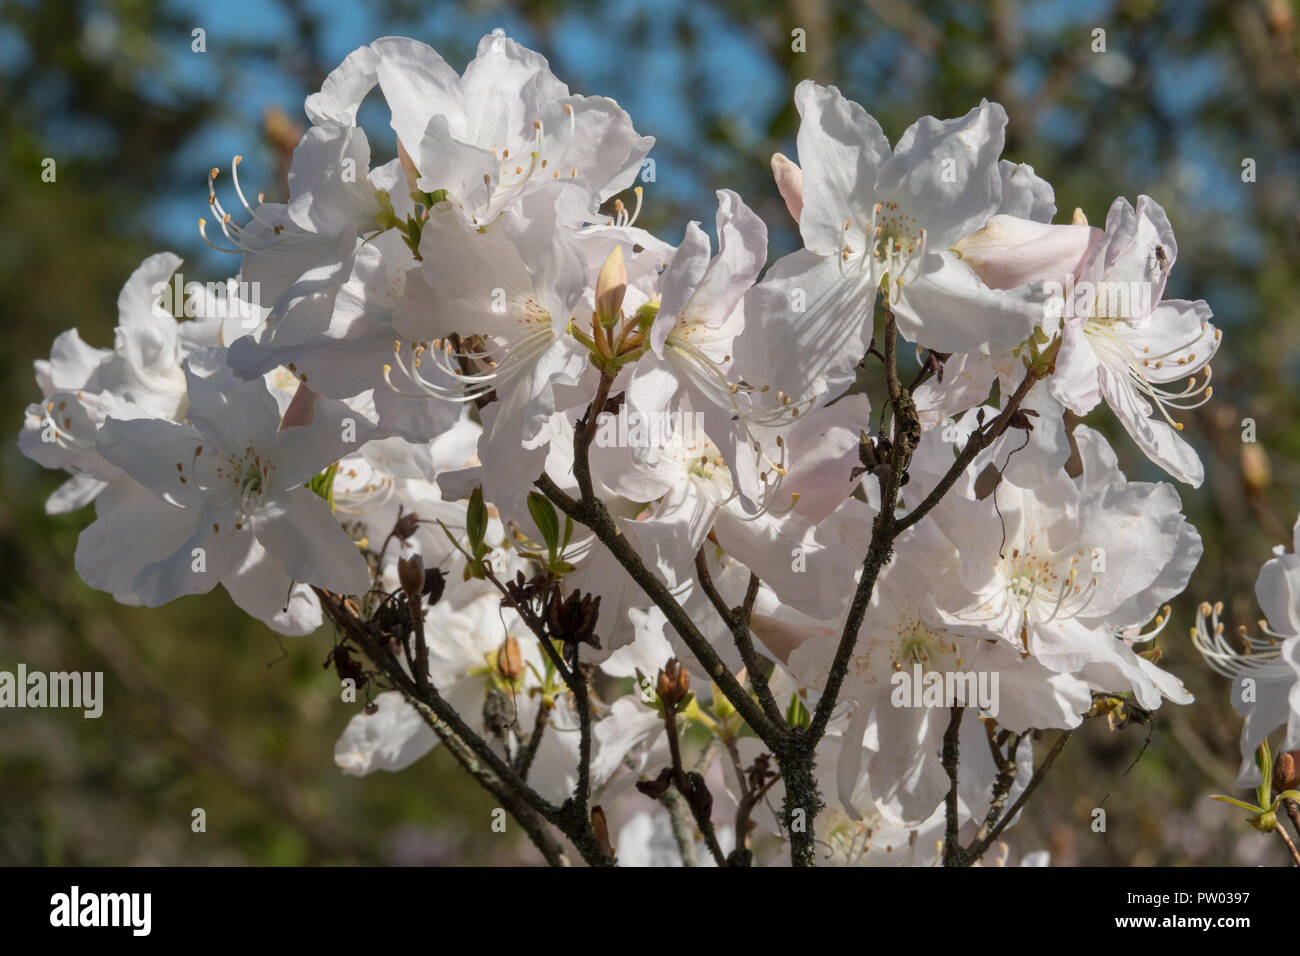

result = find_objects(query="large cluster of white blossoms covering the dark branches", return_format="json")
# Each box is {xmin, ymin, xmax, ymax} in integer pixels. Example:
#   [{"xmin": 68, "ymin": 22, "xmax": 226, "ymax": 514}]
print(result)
[{"xmin": 20, "ymin": 33, "xmax": 1222, "ymax": 864}]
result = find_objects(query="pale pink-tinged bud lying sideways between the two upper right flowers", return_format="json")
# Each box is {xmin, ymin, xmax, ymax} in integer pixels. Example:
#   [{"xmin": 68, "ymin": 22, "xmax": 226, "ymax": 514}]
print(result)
[{"xmin": 953, "ymin": 216, "xmax": 1102, "ymax": 289}]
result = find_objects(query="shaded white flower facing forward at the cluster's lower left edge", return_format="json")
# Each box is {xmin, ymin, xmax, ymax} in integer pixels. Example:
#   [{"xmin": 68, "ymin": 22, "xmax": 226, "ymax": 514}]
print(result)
[{"xmin": 77, "ymin": 363, "xmax": 371, "ymax": 607}]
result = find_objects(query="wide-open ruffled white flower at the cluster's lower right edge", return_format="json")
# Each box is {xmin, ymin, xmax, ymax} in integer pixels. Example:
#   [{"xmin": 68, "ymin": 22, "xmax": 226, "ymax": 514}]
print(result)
[{"xmin": 927, "ymin": 425, "xmax": 1201, "ymax": 710}]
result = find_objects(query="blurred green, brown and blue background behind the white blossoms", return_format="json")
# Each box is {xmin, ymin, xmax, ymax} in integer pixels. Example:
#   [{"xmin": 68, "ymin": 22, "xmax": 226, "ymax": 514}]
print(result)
[{"xmin": 0, "ymin": 0, "xmax": 1300, "ymax": 865}]
